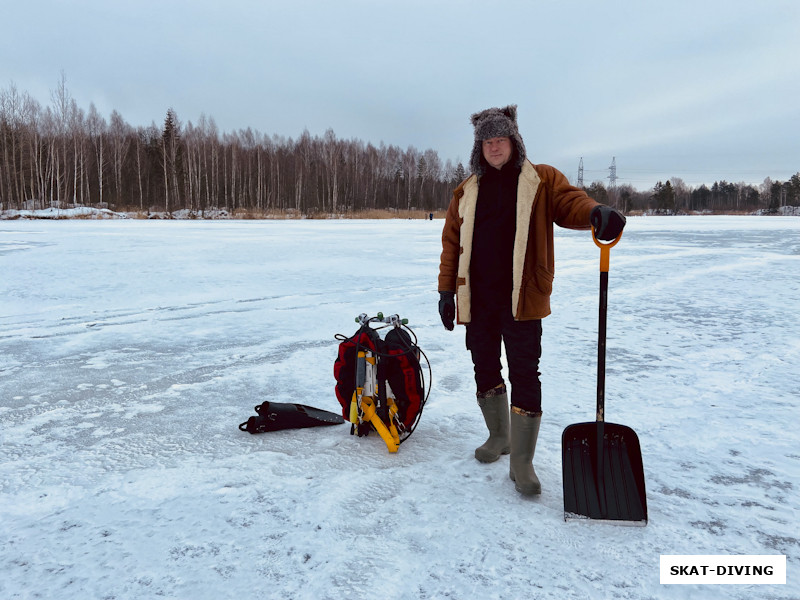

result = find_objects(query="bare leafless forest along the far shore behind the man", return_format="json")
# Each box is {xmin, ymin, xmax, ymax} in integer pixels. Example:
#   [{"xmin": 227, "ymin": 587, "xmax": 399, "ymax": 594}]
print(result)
[{"xmin": 0, "ymin": 75, "xmax": 800, "ymax": 215}]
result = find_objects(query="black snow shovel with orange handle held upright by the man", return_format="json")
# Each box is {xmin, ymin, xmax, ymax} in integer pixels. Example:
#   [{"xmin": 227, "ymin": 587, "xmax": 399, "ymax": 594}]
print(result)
[{"xmin": 561, "ymin": 228, "xmax": 647, "ymax": 526}]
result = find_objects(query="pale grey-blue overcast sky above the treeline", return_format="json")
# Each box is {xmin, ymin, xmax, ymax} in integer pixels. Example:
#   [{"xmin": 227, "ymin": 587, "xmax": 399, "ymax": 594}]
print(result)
[{"xmin": 0, "ymin": 0, "xmax": 800, "ymax": 190}]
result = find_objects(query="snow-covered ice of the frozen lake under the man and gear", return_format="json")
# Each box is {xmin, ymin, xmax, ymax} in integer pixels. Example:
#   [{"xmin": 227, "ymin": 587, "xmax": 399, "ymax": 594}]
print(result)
[{"xmin": 0, "ymin": 217, "xmax": 800, "ymax": 600}]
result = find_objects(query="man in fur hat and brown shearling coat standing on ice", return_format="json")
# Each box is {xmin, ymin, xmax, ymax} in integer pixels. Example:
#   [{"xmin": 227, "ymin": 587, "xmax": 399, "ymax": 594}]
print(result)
[{"xmin": 439, "ymin": 105, "xmax": 625, "ymax": 495}]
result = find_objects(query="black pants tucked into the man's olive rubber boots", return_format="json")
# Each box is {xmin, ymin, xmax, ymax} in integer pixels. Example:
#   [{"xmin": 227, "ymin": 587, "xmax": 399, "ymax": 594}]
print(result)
[{"xmin": 467, "ymin": 310, "xmax": 542, "ymax": 412}]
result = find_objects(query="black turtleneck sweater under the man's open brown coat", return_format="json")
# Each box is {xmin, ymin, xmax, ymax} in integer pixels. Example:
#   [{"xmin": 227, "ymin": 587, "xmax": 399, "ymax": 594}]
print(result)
[{"xmin": 470, "ymin": 160, "xmax": 520, "ymax": 317}]
